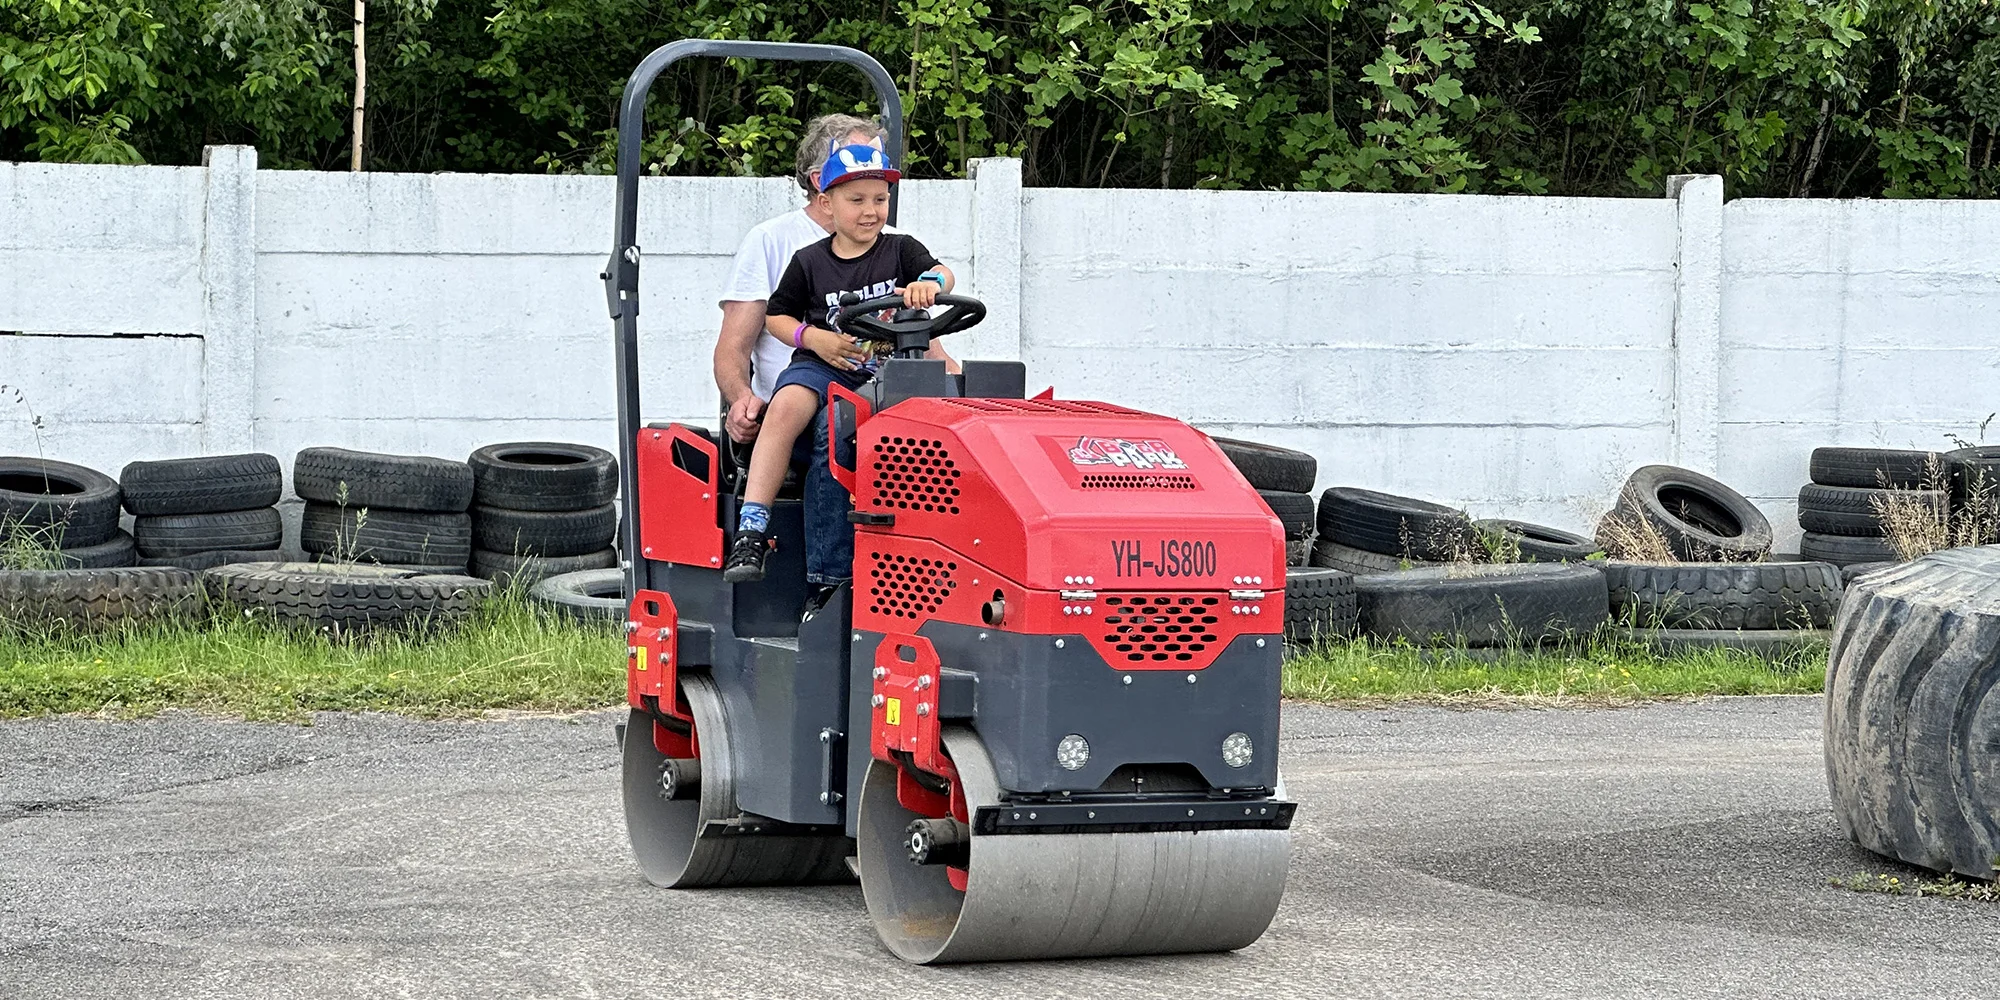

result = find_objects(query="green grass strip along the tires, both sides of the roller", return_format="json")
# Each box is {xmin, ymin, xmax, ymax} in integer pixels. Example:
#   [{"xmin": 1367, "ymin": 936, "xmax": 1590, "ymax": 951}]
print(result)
[{"xmin": 0, "ymin": 592, "xmax": 1826, "ymax": 720}]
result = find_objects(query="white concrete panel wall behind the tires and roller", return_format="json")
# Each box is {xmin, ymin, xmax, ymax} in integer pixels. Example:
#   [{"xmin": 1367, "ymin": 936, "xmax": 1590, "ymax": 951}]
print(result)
[{"xmin": 0, "ymin": 148, "xmax": 2000, "ymax": 548}]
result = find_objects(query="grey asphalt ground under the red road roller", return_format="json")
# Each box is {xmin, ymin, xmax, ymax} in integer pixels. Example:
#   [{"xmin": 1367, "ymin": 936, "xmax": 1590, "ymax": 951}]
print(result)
[{"xmin": 0, "ymin": 698, "xmax": 2000, "ymax": 1000}]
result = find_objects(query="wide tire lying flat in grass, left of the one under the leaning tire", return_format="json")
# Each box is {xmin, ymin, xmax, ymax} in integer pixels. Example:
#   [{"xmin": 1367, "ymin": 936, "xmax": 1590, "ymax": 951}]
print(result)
[{"xmin": 1354, "ymin": 562, "xmax": 1610, "ymax": 646}]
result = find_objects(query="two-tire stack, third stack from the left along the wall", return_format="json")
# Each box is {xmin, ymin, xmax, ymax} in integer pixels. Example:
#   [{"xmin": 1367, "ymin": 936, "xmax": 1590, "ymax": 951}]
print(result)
[{"xmin": 292, "ymin": 448, "xmax": 472, "ymax": 576}]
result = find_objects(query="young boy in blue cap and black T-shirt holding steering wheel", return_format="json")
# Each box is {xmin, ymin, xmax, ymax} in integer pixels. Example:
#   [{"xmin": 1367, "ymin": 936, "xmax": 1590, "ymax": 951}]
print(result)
[{"xmin": 722, "ymin": 146, "xmax": 952, "ymax": 584}]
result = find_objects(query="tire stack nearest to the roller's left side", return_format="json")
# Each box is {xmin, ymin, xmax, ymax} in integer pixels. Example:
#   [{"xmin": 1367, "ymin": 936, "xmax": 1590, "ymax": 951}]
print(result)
[{"xmin": 466, "ymin": 442, "xmax": 618, "ymax": 586}]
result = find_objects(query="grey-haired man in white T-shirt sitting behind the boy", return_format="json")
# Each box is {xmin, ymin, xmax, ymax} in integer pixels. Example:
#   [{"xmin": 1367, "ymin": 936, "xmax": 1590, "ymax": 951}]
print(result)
[{"xmin": 714, "ymin": 114, "xmax": 894, "ymax": 444}]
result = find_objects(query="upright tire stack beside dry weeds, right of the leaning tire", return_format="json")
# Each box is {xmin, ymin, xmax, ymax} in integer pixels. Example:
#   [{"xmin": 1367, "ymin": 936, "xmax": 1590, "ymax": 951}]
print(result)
[{"xmin": 1798, "ymin": 448, "xmax": 1950, "ymax": 566}]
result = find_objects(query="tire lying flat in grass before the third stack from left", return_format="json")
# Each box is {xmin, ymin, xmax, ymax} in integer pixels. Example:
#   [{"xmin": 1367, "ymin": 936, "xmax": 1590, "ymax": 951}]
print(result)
[{"xmin": 202, "ymin": 562, "xmax": 492, "ymax": 632}]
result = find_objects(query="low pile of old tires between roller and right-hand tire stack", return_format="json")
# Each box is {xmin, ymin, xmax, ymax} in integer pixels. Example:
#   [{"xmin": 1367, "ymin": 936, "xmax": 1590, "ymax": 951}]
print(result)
[{"xmin": 1216, "ymin": 438, "xmax": 1840, "ymax": 652}]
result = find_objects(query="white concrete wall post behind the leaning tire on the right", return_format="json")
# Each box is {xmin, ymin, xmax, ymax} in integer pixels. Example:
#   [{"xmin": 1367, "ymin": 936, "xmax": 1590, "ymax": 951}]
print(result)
[{"xmin": 1666, "ymin": 174, "xmax": 1722, "ymax": 474}]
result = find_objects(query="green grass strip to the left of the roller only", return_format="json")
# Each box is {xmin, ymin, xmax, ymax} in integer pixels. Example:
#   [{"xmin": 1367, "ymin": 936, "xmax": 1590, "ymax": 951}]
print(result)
[{"xmin": 0, "ymin": 596, "xmax": 624, "ymax": 720}]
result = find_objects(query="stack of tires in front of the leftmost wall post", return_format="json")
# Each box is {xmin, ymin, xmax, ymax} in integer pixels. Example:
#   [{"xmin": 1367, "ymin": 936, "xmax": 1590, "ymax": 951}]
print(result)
[{"xmin": 118, "ymin": 454, "xmax": 284, "ymax": 570}]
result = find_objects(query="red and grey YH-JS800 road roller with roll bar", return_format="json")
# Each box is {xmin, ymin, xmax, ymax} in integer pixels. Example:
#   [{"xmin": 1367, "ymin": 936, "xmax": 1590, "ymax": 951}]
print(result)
[{"xmin": 604, "ymin": 40, "xmax": 1294, "ymax": 962}]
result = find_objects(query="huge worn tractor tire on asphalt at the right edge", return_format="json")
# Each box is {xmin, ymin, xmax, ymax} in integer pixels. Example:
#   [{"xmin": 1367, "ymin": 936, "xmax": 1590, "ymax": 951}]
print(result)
[{"xmin": 1824, "ymin": 548, "xmax": 2000, "ymax": 878}]
